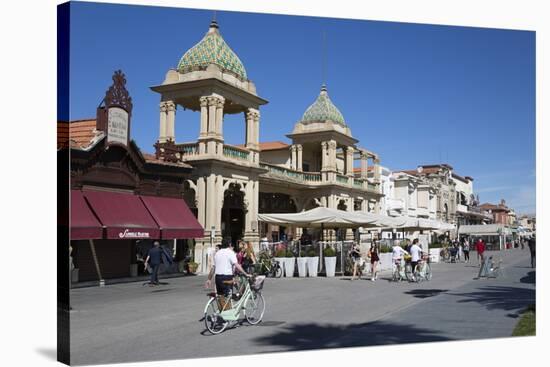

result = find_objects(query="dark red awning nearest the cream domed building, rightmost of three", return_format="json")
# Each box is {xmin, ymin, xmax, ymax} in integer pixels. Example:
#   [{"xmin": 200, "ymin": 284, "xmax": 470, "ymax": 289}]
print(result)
[{"xmin": 141, "ymin": 196, "xmax": 204, "ymax": 239}]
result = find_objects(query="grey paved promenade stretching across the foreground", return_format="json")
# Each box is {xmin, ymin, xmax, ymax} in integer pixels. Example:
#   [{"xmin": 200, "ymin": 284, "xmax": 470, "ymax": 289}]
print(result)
[{"xmin": 71, "ymin": 249, "xmax": 535, "ymax": 364}]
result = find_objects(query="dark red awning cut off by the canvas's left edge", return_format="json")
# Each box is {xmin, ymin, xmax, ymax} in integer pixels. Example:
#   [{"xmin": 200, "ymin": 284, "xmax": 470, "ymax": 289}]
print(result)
[{"xmin": 70, "ymin": 190, "xmax": 103, "ymax": 240}]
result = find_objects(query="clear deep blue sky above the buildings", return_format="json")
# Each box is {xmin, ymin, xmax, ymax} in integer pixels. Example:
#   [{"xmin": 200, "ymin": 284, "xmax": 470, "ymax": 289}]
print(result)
[{"xmin": 70, "ymin": 3, "xmax": 536, "ymax": 213}]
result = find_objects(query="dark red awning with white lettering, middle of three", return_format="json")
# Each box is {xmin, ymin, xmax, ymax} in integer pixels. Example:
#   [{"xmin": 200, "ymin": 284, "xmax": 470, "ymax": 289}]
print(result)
[{"xmin": 83, "ymin": 190, "xmax": 160, "ymax": 239}]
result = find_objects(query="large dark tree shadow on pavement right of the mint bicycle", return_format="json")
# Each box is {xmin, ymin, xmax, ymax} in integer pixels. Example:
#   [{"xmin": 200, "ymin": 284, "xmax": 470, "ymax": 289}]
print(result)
[{"xmin": 255, "ymin": 321, "xmax": 452, "ymax": 351}]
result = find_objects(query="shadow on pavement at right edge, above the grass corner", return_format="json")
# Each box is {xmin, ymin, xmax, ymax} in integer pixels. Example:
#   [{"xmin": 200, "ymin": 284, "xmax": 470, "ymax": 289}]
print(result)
[{"xmin": 448, "ymin": 286, "xmax": 535, "ymax": 311}]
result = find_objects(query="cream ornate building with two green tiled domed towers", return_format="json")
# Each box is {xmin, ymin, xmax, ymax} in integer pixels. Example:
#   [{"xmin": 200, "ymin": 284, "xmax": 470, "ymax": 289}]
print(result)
[{"xmin": 151, "ymin": 21, "xmax": 383, "ymax": 270}]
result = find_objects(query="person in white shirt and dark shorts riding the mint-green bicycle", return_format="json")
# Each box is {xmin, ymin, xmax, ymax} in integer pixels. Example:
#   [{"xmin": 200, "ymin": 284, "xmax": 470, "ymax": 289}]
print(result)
[{"xmin": 206, "ymin": 239, "xmax": 250, "ymax": 309}]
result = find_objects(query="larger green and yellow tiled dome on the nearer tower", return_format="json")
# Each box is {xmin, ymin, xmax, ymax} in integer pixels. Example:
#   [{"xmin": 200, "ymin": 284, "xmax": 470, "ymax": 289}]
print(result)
[{"xmin": 178, "ymin": 20, "xmax": 247, "ymax": 79}]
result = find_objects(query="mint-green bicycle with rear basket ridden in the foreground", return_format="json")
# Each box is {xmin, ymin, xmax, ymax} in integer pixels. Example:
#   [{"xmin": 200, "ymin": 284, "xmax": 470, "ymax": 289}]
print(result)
[{"xmin": 204, "ymin": 275, "xmax": 265, "ymax": 334}]
